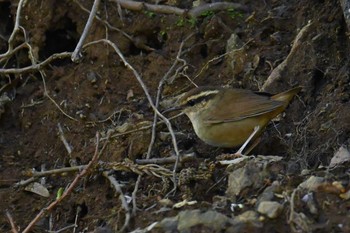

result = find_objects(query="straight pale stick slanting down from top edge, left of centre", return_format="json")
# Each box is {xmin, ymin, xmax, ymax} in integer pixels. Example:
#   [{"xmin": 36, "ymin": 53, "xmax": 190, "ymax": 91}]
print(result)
[{"xmin": 71, "ymin": 0, "xmax": 101, "ymax": 62}]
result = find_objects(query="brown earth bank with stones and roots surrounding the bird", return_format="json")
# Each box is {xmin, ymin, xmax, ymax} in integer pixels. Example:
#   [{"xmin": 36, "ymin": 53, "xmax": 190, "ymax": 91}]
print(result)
[{"xmin": 0, "ymin": 0, "xmax": 350, "ymax": 232}]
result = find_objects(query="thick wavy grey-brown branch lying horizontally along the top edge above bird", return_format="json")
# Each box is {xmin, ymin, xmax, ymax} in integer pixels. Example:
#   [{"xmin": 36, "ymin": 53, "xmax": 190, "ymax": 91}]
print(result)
[{"xmin": 110, "ymin": 0, "xmax": 248, "ymax": 17}]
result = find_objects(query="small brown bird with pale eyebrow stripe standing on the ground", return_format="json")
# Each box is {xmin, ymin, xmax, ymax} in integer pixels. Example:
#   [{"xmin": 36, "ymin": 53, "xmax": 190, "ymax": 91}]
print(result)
[{"xmin": 172, "ymin": 87, "xmax": 301, "ymax": 155}]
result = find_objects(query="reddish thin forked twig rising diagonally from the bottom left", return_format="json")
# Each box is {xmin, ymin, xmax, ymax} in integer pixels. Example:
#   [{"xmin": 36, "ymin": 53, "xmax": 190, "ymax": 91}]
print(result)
[{"xmin": 23, "ymin": 132, "xmax": 102, "ymax": 233}]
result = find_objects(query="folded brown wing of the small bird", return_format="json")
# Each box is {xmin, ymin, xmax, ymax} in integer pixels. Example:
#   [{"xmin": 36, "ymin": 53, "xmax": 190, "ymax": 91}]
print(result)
[{"xmin": 204, "ymin": 89, "xmax": 283, "ymax": 124}]
